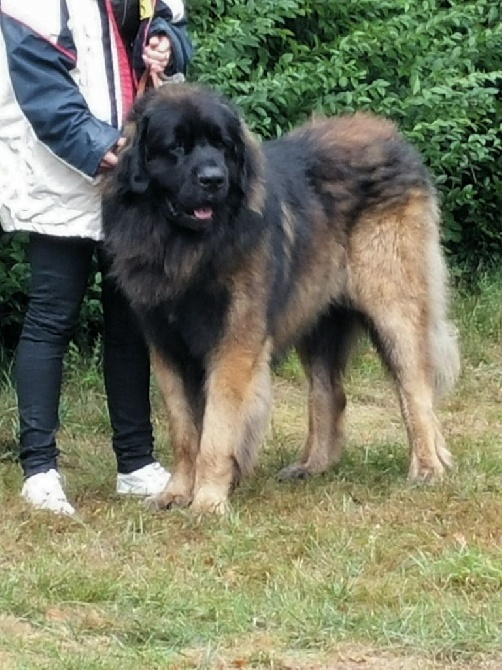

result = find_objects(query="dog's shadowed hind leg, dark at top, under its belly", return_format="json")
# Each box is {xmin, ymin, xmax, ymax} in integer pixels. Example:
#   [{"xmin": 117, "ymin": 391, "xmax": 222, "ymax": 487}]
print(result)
[{"xmin": 279, "ymin": 308, "xmax": 359, "ymax": 481}]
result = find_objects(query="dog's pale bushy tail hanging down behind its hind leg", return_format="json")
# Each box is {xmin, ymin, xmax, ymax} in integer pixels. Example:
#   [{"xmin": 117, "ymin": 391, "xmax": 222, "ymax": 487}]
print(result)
[{"xmin": 427, "ymin": 203, "xmax": 460, "ymax": 398}]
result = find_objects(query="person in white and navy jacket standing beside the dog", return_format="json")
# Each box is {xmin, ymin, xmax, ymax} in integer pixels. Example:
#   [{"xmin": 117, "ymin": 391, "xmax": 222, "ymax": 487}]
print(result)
[{"xmin": 0, "ymin": 0, "xmax": 192, "ymax": 515}]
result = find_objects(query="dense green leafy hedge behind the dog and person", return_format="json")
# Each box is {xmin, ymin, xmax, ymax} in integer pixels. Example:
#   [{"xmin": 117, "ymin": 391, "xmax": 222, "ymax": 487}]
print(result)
[{"xmin": 0, "ymin": 0, "xmax": 502, "ymax": 350}]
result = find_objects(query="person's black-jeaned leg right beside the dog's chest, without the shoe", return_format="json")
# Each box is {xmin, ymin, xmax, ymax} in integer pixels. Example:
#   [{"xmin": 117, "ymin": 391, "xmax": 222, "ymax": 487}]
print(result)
[{"xmin": 98, "ymin": 249, "xmax": 155, "ymax": 474}]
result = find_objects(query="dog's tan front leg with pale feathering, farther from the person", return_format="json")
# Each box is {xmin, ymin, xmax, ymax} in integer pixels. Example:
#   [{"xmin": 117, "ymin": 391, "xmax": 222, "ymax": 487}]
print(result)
[{"xmin": 192, "ymin": 341, "xmax": 271, "ymax": 514}]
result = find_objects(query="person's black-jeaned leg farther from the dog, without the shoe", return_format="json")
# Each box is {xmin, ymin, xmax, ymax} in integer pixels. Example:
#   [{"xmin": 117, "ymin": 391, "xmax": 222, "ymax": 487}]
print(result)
[{"xmin": 15, "ymin": 235, "xmax": 94, "ymax": 478}]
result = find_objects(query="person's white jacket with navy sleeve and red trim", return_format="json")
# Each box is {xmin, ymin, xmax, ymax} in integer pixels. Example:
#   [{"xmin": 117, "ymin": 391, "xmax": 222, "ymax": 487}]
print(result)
[{"xmin": 0, "ymin": 0, "xmax": 188, "ymax": 240}]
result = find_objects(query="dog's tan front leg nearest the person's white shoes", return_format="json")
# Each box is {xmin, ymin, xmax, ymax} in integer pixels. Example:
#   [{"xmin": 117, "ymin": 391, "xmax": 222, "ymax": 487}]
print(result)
[{"xmin": 147, "ymin": 348, "xmax": 204, "ymax": 509}]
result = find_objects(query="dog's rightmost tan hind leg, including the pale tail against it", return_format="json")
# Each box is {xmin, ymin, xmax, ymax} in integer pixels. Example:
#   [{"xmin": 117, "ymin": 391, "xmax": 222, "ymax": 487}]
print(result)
[{"xmin": 350, "ymin": 197, "xmax": 459, "ymax": 482}]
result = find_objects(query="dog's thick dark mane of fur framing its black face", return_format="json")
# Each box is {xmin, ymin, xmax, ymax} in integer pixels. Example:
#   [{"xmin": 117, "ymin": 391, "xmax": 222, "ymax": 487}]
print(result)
[{"xmin": 102, "ymin": 85, "xmax": 266, "ymax": 307}]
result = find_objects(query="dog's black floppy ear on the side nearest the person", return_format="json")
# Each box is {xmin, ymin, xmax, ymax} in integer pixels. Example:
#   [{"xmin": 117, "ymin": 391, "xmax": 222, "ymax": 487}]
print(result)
[{"xmin": 116, "ymin": 115, "xmax": 150, "ymax": 193}]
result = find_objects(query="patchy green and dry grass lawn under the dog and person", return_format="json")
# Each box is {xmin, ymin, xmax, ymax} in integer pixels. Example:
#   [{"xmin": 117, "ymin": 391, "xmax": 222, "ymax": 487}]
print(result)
[{"xmin": 0, "ymin": 280, "xmax": 502, "ymax": 670}]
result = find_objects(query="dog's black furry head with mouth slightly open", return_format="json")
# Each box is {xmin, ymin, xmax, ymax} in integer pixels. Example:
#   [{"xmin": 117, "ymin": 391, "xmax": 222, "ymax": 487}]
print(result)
[{"xmin": 115, "ymin": 84, "xmax": 261, "ymax": 230}]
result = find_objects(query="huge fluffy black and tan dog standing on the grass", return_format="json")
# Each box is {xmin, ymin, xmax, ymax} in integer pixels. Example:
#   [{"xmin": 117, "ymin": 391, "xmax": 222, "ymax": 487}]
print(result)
[{"xmin": 104, "ymin": 85, "xmax": 458, "ymax": 512}]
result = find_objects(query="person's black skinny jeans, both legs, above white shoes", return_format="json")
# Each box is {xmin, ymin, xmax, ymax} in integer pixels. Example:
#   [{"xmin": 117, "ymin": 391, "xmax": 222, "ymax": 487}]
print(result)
[{"xmin": 16, "ymin": 234, "xmax": 154, "ymax": 477}]
